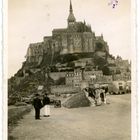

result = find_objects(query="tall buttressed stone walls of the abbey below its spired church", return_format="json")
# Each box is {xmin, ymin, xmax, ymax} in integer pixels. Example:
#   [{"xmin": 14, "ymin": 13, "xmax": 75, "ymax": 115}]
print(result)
[{"xmin": 26, "ymin": 25, "xmax": 108, "ymax": 63}]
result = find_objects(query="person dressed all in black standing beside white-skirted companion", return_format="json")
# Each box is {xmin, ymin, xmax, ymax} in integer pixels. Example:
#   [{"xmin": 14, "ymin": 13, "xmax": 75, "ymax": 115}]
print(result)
[{"xmin": 33, "ymin": 94, "xmax": 42, "ymax": 120}]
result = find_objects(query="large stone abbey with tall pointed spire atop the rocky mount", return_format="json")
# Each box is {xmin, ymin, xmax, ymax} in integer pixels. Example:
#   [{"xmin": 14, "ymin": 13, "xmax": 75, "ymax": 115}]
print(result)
[{"xmin": 26, "ymin": 1, "xmax": 109, "ymax": 63}]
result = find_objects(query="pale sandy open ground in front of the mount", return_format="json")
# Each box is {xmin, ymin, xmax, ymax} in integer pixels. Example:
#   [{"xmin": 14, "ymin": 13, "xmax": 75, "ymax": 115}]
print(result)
[{"xmin": 12, "ymin": 94, "xmax": 131, "ymax": 140}]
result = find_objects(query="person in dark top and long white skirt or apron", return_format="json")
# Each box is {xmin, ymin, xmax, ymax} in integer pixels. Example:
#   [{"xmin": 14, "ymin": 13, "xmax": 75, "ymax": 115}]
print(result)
[{"xmin": 43, "ymin": 94, "xmax": 50, "ymax": 117}]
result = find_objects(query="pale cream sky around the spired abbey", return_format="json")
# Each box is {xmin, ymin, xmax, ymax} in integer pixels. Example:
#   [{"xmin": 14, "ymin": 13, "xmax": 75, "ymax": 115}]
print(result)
[{"xmin": 8, "ymin": 0, "xmax": 132, "ymax": 78}]
